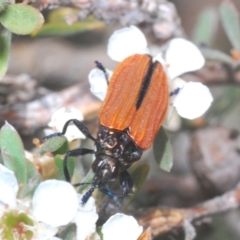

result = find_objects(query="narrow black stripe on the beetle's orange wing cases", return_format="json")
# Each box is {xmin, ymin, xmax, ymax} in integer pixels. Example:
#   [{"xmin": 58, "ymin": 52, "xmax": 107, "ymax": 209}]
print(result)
[{"xmin": 136, "ymin": 60, "xmax": 158, "ymax": 110}]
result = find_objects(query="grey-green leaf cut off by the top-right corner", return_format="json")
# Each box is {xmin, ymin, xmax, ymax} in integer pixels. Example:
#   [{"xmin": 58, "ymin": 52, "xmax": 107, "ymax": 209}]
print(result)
[{"xmin": 220, "ymin": 0, "xmax": 240, "ymax": 51}]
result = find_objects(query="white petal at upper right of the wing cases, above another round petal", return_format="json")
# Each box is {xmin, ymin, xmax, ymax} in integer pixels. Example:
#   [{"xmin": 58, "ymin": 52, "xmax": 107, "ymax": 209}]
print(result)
[{"xmin": 165, "ymin": 38, "xmax": 205, "ymax": 79}]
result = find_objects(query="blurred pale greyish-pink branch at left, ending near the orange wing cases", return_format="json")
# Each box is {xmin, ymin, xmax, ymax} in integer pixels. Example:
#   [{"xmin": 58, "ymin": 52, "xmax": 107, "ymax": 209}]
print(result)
[{"xmin": 0, "ymin": 77, "xmax": 101, "ymax": 135}]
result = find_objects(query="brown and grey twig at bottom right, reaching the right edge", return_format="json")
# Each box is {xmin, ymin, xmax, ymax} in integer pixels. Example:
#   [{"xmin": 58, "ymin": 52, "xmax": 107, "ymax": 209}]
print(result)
[{"xmin": 137, "ymin": 183, "xmax": 240, "ymax": 239}]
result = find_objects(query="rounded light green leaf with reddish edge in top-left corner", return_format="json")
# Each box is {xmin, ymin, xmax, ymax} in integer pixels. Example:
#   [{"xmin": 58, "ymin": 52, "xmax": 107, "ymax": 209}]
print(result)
[{"xmin": 0, "ymin": 4, "xmax": 44, "ymax": 35}]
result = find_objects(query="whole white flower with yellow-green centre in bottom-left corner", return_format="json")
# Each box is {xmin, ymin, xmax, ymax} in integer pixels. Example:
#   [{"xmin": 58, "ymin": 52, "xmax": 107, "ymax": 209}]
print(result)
[{"xmin": 0, "ymin": 164, "xmax": 98, "ymax": 240}]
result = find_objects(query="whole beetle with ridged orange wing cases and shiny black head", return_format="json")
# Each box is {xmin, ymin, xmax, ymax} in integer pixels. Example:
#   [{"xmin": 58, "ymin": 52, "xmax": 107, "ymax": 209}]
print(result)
[{"xmin": 46, "ymin": 54, "xmax": 169, "ymax": 204}]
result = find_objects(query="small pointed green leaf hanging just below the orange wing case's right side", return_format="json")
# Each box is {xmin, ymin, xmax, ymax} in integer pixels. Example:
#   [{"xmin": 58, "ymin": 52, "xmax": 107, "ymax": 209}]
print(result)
[{"xmin": 153, "ymin": 127, "xmax": 173, "ymax": 172}]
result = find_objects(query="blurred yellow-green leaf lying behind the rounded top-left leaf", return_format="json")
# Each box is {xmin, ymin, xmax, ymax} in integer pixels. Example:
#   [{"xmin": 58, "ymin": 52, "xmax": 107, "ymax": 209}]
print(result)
[{"xmin": 32, "ymin": 21, "xmax": 105, "ymax": 37}]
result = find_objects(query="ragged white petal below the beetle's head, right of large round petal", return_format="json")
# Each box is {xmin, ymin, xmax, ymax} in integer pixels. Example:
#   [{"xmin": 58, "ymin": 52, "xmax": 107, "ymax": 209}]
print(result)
[{"xmin": 73, "ymin": 194, "xmax": 98, "ymax": 240}]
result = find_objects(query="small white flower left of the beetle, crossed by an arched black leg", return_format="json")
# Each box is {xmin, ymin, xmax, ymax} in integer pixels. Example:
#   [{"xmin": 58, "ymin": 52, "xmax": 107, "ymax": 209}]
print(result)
[{"xmin": 47, "ymin": 107, "xmax": 86, "ymax": 142}]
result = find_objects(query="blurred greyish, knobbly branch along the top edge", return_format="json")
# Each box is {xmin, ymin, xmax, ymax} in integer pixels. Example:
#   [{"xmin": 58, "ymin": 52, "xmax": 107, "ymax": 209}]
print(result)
[{"xmin": 24, "ymin": 0, "xmax": 184, "ymax": 40}]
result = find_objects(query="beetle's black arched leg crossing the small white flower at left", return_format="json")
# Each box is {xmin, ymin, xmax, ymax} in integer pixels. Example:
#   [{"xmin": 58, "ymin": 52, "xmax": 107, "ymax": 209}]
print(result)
[{"xmin": 43, "ymin": 119, "xmax": 96, "ymax": 142}]
